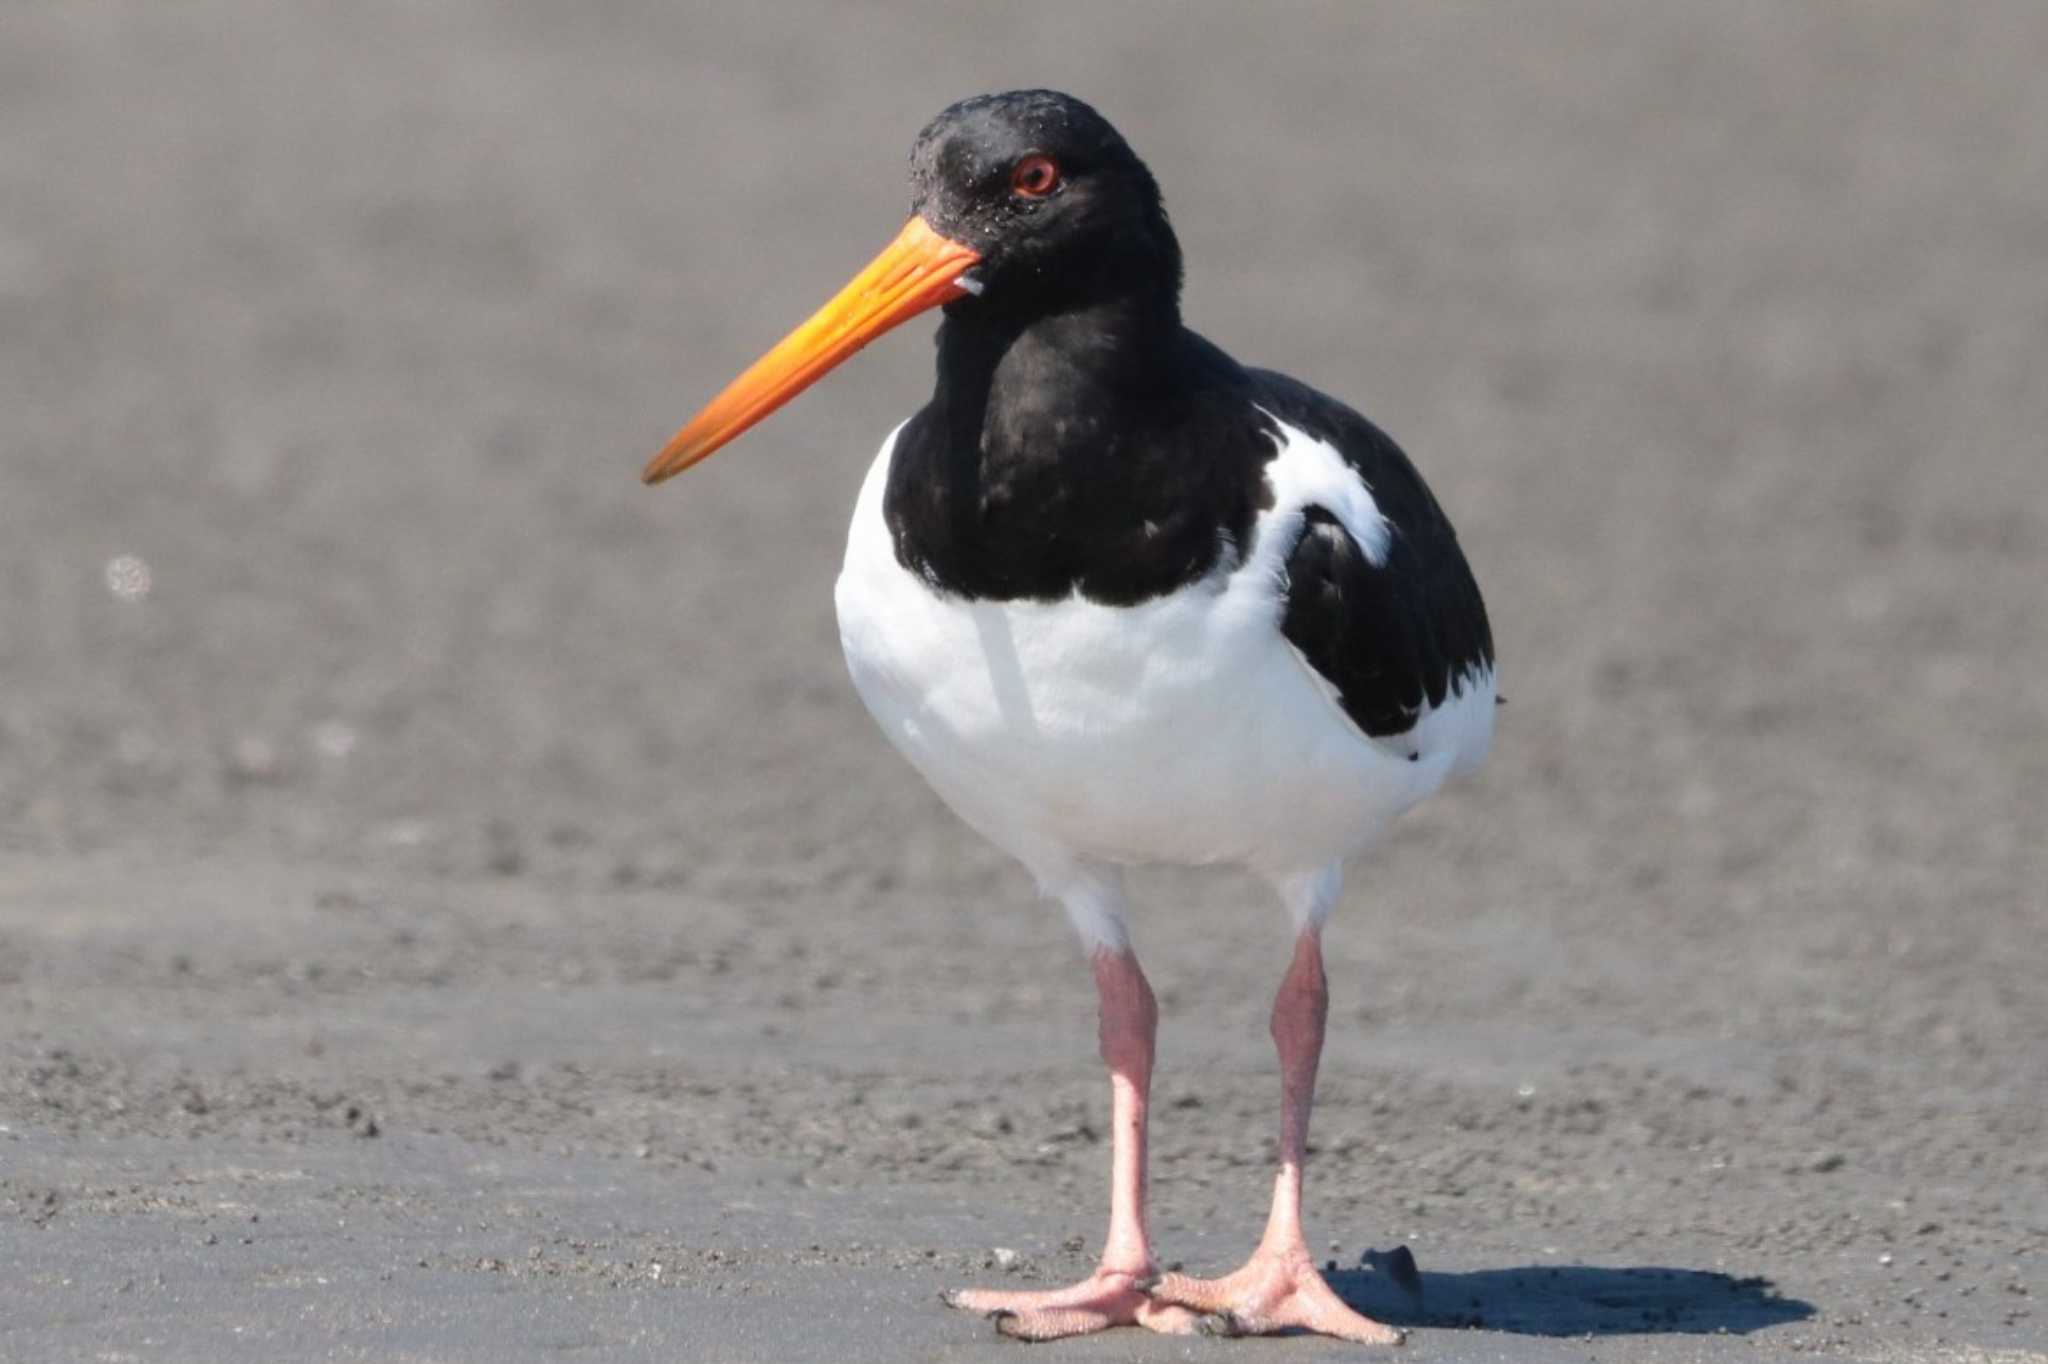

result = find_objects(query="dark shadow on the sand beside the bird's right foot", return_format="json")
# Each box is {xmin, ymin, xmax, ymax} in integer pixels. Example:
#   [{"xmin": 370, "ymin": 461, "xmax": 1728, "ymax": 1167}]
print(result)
[{"xmin": 1325, "ymin": 1245, "xmax": 1815, "ymax": 1335}]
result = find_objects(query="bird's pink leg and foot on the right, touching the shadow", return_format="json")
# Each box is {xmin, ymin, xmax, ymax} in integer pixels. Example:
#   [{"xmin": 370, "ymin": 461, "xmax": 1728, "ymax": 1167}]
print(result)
[{"xmin": 1153, "ymin": 924, "xmax": 1403, "ymax": 1346}]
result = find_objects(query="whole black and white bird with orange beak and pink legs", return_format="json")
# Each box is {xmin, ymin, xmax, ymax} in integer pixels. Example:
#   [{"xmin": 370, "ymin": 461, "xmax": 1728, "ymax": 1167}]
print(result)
[{"xmin": 645, "ymin": 90, "xmax": 1495, "ymax": 1344}]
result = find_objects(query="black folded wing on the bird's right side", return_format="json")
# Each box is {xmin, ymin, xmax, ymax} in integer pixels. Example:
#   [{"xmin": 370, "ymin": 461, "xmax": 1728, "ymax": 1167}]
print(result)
[{"xmin": 1247, "ymin": 369, "xmax": 1493, "ymax": 737}]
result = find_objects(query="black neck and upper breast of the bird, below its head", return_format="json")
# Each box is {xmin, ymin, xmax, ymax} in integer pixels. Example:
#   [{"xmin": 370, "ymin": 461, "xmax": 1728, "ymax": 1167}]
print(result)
[{"xmin": 885, "ymin": 289, "xmax": 1270, "ymax": 602}]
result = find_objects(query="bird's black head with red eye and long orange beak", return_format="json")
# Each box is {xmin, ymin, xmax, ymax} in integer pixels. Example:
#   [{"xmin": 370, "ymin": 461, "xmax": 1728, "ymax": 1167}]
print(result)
[{"xmin": 641, "ymin": 90, "xmax": 1180, "ymax": 483}]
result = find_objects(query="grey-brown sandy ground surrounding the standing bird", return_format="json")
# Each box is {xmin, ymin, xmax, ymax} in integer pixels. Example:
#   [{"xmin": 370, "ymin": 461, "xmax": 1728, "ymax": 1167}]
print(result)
[{"xmin": 0, "ymin": 0, "xmax": 2048, "ymax": 1364}]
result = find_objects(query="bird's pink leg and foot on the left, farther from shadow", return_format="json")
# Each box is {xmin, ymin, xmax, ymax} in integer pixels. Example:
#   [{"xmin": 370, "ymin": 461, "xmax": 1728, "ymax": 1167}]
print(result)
[{"xmin": 946, "ymin": 948, "xmax": 1200, "ymax": 1339}]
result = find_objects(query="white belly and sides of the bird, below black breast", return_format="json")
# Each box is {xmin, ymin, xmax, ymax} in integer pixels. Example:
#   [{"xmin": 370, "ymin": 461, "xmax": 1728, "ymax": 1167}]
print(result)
[{"xmin": 838, "ymin": 413, "xmax": 1493, "ymax": 881}]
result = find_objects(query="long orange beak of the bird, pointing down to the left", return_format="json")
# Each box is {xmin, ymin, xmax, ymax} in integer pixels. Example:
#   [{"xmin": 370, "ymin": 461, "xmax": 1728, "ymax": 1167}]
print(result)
[{"xmin": 641, "ymin": 217, "xmax": 981, "ymax": 483}]
